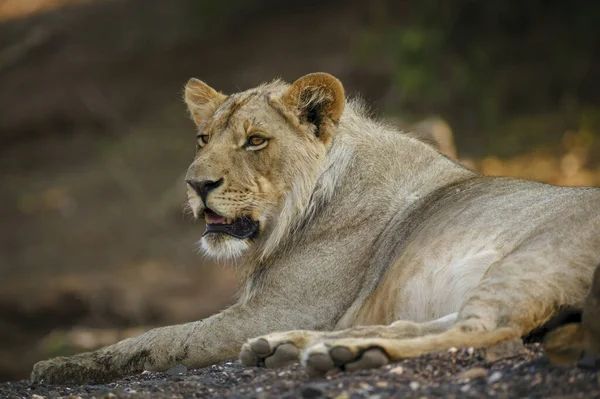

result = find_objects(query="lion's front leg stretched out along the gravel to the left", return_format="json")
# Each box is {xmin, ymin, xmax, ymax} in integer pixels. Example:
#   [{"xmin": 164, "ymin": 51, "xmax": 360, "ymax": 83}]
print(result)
[{"xmin": 31, "ymin": 304, "xmax": 303, "ymax": 383}]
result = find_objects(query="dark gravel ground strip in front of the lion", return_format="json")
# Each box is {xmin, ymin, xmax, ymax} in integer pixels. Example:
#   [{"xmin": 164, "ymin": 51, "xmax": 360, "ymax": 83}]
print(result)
[{"xmin": 0, "ymin": 344, "xmax": 600, "ymax": 399}]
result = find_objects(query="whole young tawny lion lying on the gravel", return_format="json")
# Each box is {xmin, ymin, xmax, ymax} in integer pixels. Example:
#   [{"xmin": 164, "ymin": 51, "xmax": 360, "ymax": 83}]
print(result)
[{"xmin": 31, "ymin": 73, "xmax": 600, "ymax": 383}]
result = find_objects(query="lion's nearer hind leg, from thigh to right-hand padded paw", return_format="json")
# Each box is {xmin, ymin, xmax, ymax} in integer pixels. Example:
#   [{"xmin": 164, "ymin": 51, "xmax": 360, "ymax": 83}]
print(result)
[{"xmin": 301, "ymin": 254, "xmax": 593, "ymax": 375}]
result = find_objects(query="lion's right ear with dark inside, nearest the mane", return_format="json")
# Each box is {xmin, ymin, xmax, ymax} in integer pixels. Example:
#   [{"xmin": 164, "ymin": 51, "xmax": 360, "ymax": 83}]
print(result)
[{"xmin": 282, "ymin": 73, "xmax": 345, "ymax": 143}]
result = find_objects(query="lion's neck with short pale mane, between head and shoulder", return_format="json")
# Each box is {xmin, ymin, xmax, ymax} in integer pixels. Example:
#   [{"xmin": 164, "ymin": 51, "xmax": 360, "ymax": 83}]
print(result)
[{"xmin": 260, "ymin": 103, "xmax": 474, "ymax": 262}]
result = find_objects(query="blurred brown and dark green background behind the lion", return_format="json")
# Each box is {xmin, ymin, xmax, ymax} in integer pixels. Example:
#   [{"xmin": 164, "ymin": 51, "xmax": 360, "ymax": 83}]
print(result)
[{"xmin": 0, "ymin": 0, "xmax": 600, "ymax": 380}]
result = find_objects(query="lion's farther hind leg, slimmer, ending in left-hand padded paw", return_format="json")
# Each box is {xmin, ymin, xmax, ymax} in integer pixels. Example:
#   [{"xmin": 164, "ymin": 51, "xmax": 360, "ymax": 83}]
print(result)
[{"xmin": 240, "ymin": 313, "xmax": 457, "ymax": 368}]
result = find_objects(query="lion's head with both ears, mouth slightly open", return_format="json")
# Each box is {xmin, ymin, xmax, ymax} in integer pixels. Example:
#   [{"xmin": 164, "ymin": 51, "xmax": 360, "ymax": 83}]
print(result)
[{"xmin": 185, "ymin": 73, "xmax": 345, "ymax": 259}]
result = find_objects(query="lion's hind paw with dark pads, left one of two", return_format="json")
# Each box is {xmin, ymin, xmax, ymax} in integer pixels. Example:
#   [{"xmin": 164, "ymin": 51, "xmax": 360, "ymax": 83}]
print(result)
[{"xmin": 240, "ymin": 331, "xmax": 320, "ymax": 368}]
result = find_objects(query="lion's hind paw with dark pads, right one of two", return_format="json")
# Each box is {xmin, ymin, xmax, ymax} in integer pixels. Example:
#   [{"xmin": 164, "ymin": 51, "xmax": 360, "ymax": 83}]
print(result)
[{"xmin": 302, "ymin": 339, "xmax": 390, "ymax": 377}]
